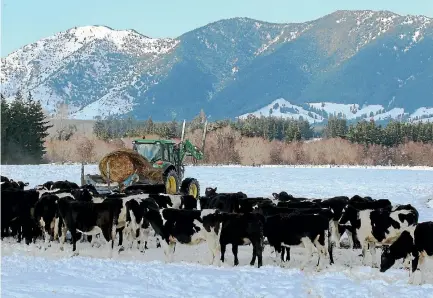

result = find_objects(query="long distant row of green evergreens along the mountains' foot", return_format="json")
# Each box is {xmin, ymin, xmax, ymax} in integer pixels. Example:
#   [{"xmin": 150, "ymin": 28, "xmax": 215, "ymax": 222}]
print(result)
[{"xmin": 94, "ymin": 111, "xmax": 433, "ymax": 147}]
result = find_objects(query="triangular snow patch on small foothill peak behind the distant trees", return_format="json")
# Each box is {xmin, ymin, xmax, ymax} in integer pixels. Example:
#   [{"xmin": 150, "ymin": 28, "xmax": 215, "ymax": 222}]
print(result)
[{"xmin": 239, "ymin": 98, "xmax": 323, "ymax": 123}]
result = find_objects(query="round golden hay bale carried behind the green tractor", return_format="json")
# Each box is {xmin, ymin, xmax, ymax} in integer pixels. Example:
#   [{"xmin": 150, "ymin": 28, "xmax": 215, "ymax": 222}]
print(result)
[{"xmin": 99, "ymin": 148, "xmax": 163, "ymax": 183}]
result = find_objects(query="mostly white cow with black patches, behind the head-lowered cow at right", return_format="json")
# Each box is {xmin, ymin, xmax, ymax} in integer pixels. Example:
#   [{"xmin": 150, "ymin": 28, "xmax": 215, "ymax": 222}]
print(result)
[{"xmin": 340, "ymin": 204, "xmax": 419, "ymax": 267}]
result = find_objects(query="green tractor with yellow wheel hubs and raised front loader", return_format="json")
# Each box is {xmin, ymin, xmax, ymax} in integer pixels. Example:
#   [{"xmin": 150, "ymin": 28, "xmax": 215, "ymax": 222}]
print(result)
[{"xmin": 82, "ymin": 121, "xmax": 207, "ymax": 199}]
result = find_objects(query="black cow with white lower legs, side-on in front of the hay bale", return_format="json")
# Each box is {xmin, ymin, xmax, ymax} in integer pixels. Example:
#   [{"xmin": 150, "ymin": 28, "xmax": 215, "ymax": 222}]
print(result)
[{"xmin": 57, "ymin": 198, "xmax": 123, "ymax": 257}]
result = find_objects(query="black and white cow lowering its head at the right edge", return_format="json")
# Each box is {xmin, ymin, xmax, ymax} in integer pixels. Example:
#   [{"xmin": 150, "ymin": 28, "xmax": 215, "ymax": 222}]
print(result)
[{"xmin": 380, "ymin": 221, "xmax": 433, "ymax": 284}]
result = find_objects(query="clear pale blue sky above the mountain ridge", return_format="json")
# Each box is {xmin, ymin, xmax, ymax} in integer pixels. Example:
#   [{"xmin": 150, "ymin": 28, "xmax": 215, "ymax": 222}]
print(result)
[{"xmin": 1, "ymin": 0, "xmax": 433, "ymax": 57}]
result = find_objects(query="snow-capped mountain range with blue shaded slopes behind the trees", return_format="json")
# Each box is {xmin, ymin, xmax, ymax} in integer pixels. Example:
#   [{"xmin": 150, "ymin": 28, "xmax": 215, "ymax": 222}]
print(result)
[{"xmin": 0, "ymin": 11, "xmax": 433, "ymax": 122}]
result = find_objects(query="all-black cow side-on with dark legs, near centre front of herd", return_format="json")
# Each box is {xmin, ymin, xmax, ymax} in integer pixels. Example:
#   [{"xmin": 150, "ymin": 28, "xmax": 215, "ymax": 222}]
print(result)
[{"xmin": 203, "ymin": 212, "xmax": 265, "ymax": 268}]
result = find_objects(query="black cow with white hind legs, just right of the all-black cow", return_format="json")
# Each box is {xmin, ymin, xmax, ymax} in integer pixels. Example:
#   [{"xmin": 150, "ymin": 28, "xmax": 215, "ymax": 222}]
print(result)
[{"xmin": 264, "ymin": 213, "xmax": 334, "ymax": 270}]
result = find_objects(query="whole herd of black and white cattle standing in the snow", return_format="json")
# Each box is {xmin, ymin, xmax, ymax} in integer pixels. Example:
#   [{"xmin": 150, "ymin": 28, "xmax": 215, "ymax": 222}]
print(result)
[{"xmin": 1, "ymin": 176, "xmax": 433, "ymax": 283}]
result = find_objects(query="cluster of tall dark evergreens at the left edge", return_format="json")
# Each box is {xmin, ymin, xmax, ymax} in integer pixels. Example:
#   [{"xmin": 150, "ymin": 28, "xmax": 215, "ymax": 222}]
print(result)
[{"xmin": 1, "ymin": 92, "xmax": 52, "ymax": 164}]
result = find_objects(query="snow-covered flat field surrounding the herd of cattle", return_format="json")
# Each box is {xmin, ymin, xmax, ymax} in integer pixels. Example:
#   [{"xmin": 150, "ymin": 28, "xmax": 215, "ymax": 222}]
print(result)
[{"xmin": 1, "ymin": 165, "xmax": 433, "ymax": 298}]
